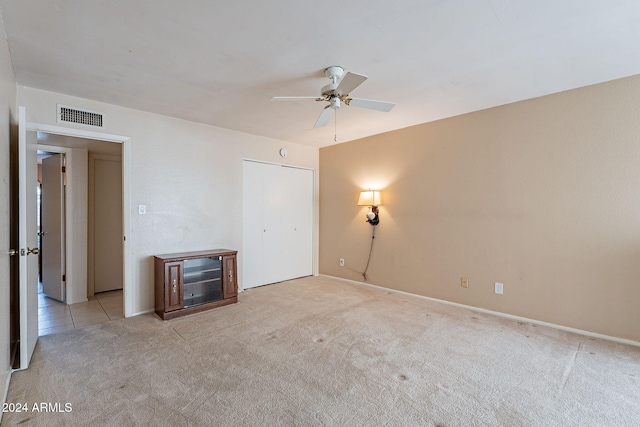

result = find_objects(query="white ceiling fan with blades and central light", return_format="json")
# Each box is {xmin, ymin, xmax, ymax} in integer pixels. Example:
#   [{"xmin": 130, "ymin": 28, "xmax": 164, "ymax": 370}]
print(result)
[{"xmin": 271, "ymin": 65, "xmax": 396, "ymax": 128}]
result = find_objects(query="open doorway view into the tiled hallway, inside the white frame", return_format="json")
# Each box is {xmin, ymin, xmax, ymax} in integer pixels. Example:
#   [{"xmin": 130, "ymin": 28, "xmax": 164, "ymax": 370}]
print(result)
[{"xmin": 38, "ymin": 139, "xmax": 124, "ymax": 336}]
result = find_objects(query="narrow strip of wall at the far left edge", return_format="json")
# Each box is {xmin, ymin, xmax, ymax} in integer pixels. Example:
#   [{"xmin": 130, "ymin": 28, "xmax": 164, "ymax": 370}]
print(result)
[{"xmin": 0, "ymin": 15, "xmax": 17, "ymax": 412}]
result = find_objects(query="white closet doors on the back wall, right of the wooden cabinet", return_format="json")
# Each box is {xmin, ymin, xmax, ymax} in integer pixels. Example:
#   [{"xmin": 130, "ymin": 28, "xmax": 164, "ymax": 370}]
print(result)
[{"xmin": 243, "ymin": 161, "xmax": 313, "ymax": 288}]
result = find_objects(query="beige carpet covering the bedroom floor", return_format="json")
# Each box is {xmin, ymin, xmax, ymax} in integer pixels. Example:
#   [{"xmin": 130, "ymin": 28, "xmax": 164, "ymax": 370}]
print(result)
[{"xmin": 2, "ymin": 277, "xmax": 640, "ymax": 426}]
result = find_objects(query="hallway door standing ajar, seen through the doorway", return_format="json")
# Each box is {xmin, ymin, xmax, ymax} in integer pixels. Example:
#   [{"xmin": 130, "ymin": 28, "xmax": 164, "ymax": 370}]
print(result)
[{"xmin": 40, "ymin": 154, "xmax": 65, "ymax": 301}]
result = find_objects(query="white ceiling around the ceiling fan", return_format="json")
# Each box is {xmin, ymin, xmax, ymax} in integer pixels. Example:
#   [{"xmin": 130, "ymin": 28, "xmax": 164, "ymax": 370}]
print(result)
[{"xmin": 0, "ymin": 0, "xmax": 640, "ymax": 147}]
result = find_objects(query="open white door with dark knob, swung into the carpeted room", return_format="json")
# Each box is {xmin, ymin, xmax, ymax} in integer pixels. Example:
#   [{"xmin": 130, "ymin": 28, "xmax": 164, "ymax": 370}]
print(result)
[{"xmin": 18, "ymin": 107, "xmax": 38, "ymax": 369}]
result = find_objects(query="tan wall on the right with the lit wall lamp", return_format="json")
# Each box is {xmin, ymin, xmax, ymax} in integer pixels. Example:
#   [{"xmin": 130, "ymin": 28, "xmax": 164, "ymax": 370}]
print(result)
[{"xmin": 320, "ymin": 76, "xmax": 640, "ymax": 341}]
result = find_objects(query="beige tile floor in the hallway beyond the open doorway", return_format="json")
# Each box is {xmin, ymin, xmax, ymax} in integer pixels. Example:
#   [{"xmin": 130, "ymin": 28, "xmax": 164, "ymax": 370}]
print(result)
[{"xmin": 38, "ymin": 290, "xmax": 124, "ymax": 336}]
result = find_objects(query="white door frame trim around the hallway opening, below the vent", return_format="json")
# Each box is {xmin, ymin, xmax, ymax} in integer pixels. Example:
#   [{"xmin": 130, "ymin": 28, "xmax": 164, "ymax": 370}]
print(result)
[{"xmin": 26, "ymin": 122, "xmax": 134, "ymax": 317}]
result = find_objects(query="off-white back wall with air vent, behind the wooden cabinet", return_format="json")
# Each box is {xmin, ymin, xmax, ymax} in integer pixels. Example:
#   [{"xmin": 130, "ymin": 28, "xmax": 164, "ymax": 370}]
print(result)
[{"xmin": 18, "ymin": 86, "xmax": 318, "ymax": 314}]
